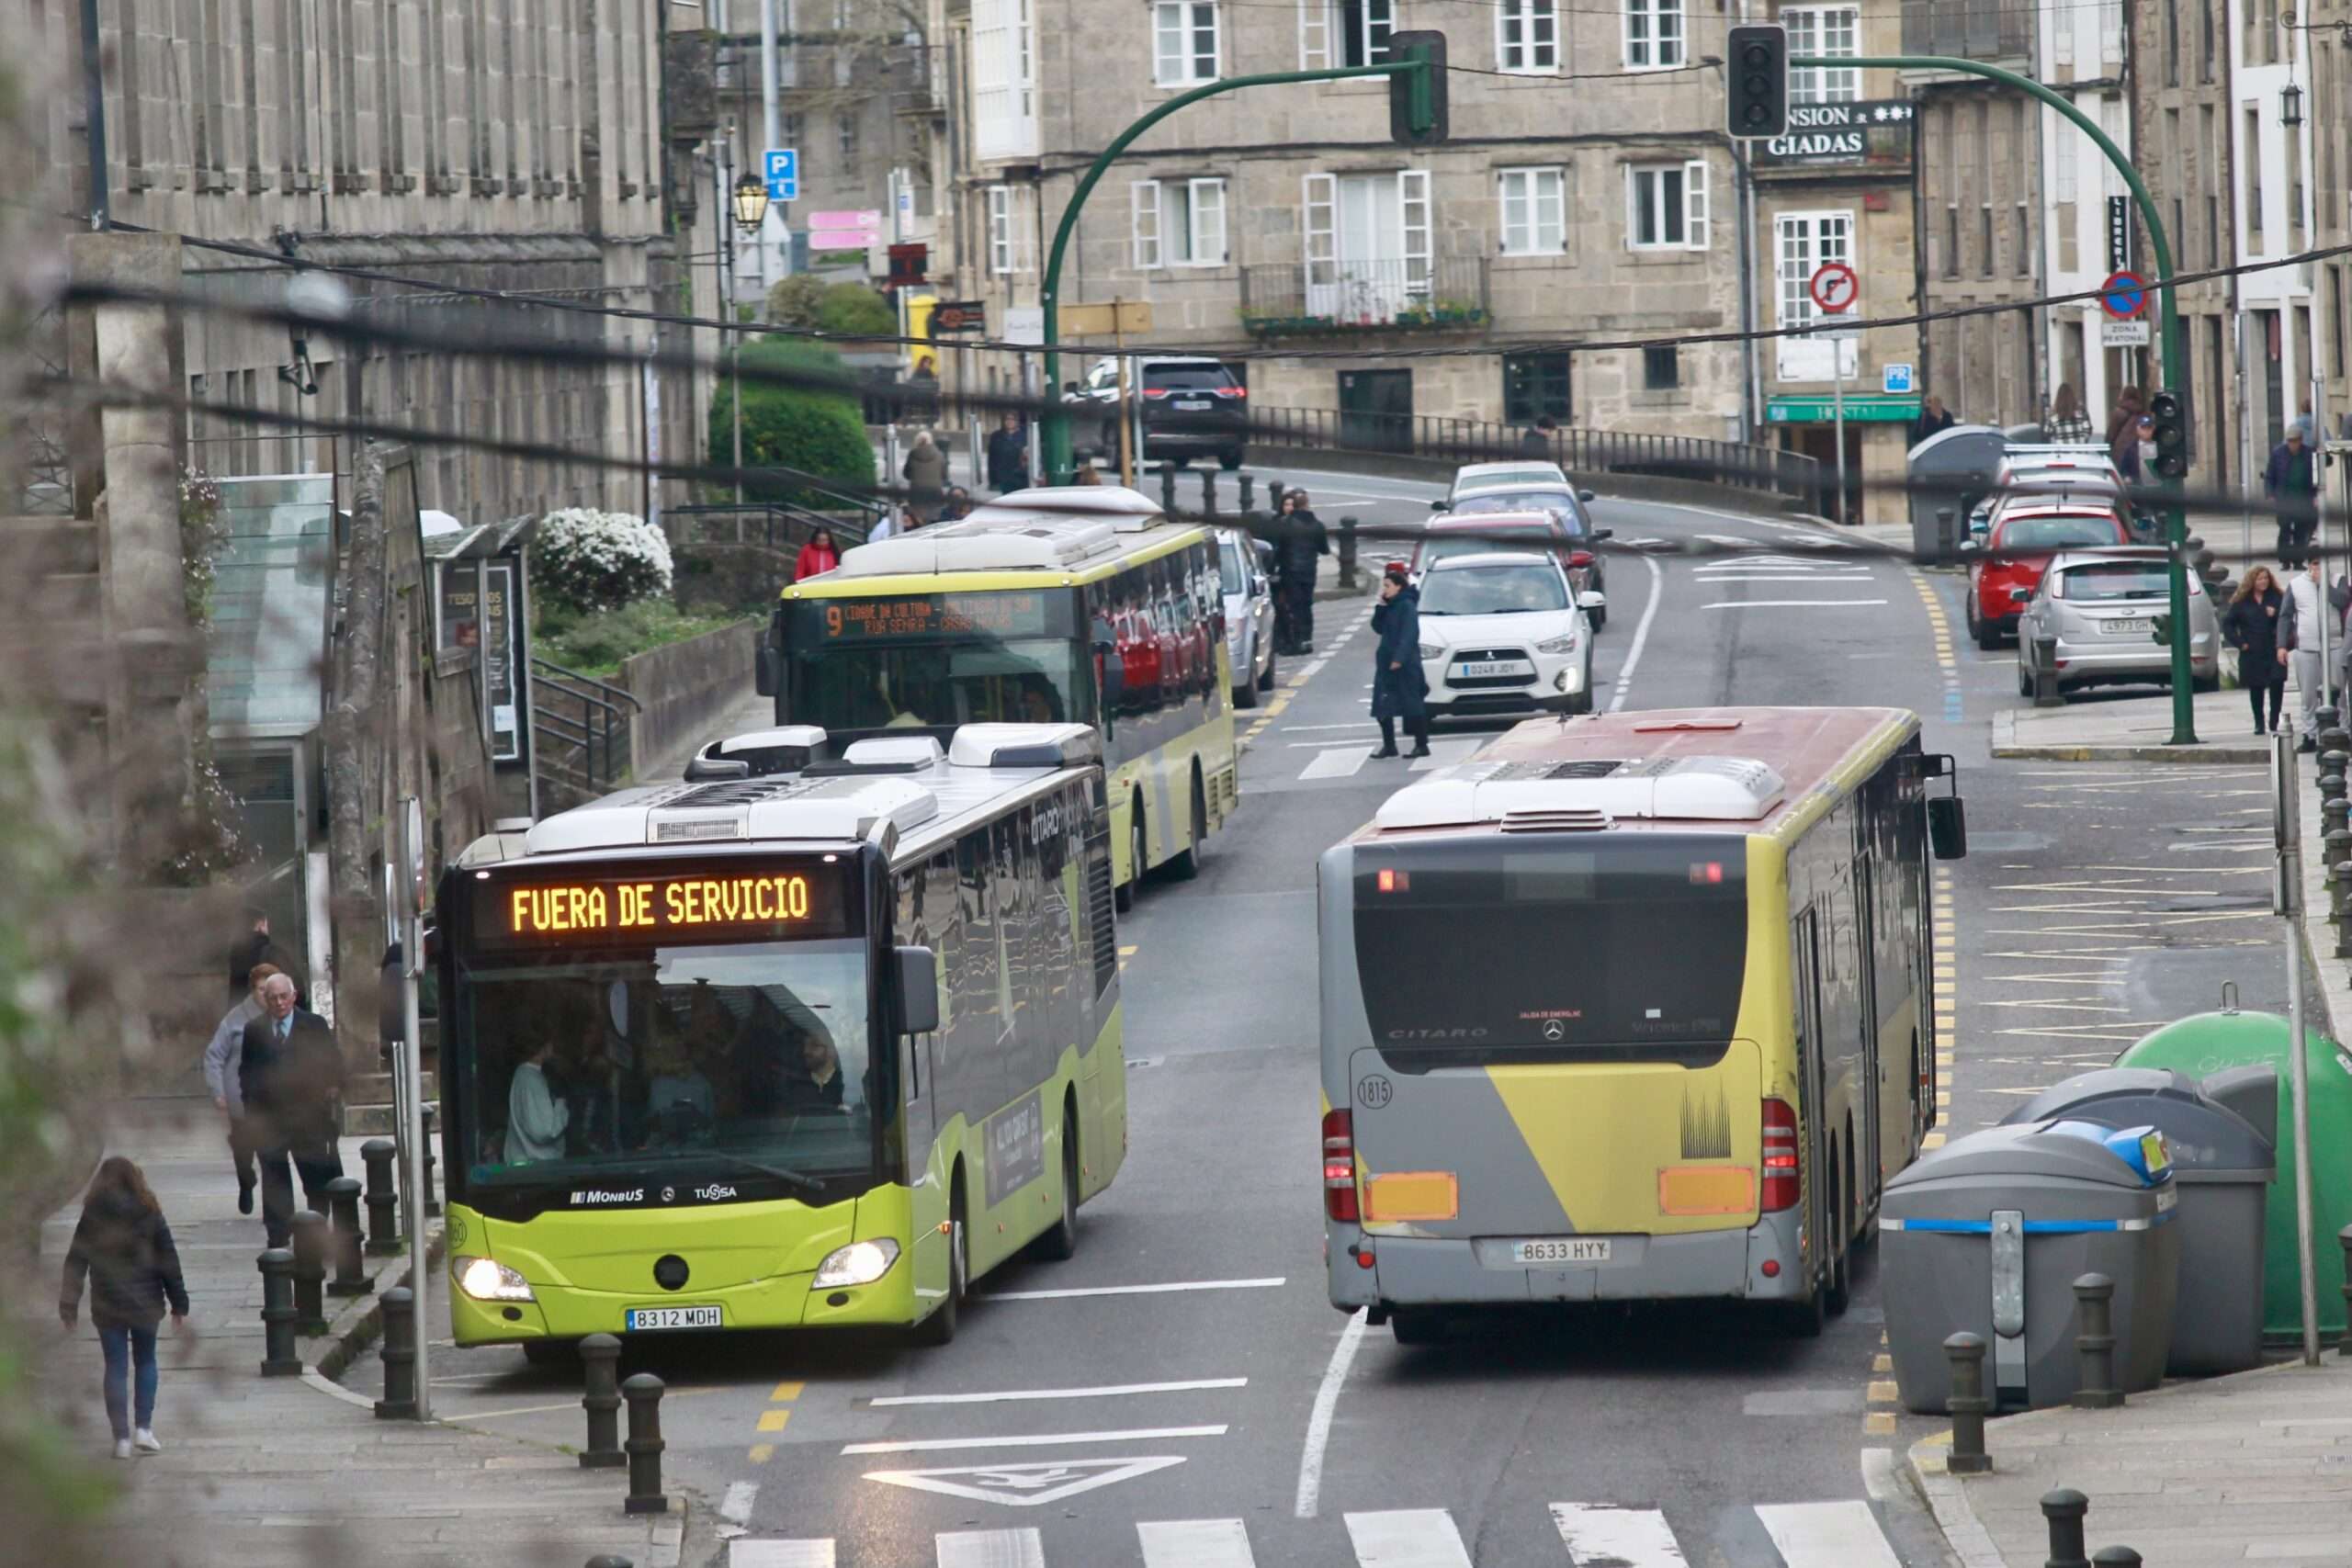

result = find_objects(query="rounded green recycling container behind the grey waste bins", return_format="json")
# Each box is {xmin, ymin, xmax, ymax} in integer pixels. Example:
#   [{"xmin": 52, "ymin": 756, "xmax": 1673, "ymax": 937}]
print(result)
[{"xmin": 2114, "ymin": 1010, "xmax": 2352, "ymax": 1340}]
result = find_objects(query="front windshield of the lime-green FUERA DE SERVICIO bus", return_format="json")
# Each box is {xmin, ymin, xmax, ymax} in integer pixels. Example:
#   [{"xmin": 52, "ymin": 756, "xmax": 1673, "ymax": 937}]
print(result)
[{"xmin": 454, "ymin": 938, "xmax": 877, "ymax": 1197}]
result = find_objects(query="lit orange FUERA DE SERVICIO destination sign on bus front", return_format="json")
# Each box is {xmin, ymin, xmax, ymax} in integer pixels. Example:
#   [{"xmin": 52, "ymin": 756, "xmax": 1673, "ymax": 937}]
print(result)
[{"xmin": 473, "ymin": 867, "xmax": 844, "ymax": 947}]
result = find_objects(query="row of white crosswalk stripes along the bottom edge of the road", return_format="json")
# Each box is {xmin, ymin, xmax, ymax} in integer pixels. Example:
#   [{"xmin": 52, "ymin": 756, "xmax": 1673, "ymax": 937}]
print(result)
[{"xmin": 727, "ymin": 1497, "xmax": 1903, "ymax": 1568}]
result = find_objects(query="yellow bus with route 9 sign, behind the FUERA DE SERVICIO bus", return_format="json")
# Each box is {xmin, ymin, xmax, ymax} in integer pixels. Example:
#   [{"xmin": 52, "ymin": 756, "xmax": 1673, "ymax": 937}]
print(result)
[{"xmin": 760, "ymin": 484, "xmax": 1239, "ymax": 909}]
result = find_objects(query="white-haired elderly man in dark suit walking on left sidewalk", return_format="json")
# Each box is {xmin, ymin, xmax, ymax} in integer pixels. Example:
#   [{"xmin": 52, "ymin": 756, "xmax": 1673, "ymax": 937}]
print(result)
[{"xmin": 238, "ymin": 974, "xmax": 344, "ymax": 1246}]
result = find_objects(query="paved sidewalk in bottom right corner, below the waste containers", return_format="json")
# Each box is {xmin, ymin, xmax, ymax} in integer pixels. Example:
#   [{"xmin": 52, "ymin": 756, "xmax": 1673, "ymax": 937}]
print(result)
[{"xmin": 1910, "ymin": 1354, "xmax": 2352, "ymax": 1568}]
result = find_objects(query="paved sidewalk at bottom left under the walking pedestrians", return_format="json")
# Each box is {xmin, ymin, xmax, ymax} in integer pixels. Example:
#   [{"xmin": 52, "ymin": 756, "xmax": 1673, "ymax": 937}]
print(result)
[{"xmin": 30, "ymin": 1100, "xmax": 715, "ymax": 1568}]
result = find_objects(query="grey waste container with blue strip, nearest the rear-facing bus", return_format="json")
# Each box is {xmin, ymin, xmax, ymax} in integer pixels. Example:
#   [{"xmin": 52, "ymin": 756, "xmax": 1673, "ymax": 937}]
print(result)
[{"xmin": 1879, "ymin": 1122, "xmax": 2180, "ymax": 1416}]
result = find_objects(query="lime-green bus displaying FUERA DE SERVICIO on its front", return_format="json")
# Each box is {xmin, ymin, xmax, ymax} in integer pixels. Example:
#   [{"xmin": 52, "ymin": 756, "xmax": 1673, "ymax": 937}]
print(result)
[{"xmin": 437, "ymin": 724, "xmax": 1126, "ymax": 1359}]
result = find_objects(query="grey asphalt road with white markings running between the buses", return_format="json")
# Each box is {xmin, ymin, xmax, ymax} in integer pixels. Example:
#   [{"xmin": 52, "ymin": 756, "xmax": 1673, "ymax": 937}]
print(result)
[{"xmin": 360, "ymin": 472, "xmax": 2284, "ymax": 1568}]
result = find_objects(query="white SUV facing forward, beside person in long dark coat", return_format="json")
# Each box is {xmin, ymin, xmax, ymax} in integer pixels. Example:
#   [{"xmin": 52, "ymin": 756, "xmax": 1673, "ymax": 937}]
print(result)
[{"xmin": 1420, "ymin": 552, "xmax": 1592, "ymax": 717}]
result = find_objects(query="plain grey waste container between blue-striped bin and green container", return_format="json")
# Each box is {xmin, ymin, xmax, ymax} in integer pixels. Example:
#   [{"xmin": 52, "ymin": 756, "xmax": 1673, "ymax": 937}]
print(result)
[{"xmin": 2007, "ymin": 1067, "xmax": 2279, "ymax": 1378}]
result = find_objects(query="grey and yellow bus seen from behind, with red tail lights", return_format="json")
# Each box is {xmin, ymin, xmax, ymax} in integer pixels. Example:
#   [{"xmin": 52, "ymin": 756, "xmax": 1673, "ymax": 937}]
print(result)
[{"xmin": 1317, "ymin": 707, "xmax": 1966, "ymax": 1342}]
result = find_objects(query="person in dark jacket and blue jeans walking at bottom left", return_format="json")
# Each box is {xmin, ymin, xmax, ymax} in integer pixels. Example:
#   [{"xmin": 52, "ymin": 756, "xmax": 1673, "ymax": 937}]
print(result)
[{"xmin": 56, "ymin": 1155, "xmax": 188, "ymax": 1460}]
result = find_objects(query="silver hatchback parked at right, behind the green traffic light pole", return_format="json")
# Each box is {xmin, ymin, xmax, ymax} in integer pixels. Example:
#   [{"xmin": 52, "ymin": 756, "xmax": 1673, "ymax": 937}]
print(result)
[{"xmin": 2018, "ymin": 550, "xmax": 2221, "ymax": 696}]
